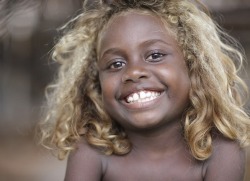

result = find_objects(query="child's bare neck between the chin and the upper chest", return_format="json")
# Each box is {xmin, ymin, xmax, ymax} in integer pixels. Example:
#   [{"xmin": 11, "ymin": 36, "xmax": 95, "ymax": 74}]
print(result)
[{"xmin": 127, "ymin": 121, "xmax": 185, "ymax": 156}]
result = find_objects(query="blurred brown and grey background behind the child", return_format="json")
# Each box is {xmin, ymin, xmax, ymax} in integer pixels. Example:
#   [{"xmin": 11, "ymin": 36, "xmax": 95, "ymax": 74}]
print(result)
[{"xmin": 0, "ymin": 0, "xmax": 250, "ymax": 181}]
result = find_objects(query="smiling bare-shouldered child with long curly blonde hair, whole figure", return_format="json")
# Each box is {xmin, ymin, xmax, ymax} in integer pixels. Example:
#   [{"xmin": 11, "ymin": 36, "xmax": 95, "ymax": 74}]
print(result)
[{"xmin": 40, "ymin": 0, "xmax": 250, "ymax": 181}]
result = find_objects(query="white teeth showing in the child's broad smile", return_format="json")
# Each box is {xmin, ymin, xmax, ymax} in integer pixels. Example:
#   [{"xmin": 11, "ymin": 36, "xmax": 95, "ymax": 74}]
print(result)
[{"xmin": 125, "ymin": 90, "xmax": 161, "ymax": 104}]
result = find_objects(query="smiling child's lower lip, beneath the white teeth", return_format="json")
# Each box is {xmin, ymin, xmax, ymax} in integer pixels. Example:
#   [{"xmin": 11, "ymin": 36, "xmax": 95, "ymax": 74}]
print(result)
[{"xmin": 122, "ymin": 92, "xmax": 164, "ymax": 111}]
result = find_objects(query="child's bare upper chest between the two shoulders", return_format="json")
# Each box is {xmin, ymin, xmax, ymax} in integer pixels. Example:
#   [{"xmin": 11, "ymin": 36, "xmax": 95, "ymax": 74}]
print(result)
[{"xmin": 102, "ymin": 155, "xmax": 203, "ymax": 181}]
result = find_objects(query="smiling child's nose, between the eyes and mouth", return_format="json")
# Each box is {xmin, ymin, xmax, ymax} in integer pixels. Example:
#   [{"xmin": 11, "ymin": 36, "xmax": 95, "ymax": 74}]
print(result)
[{"xmin": 122, "ymin": 63, "xmax": 150, "ymax": 83}]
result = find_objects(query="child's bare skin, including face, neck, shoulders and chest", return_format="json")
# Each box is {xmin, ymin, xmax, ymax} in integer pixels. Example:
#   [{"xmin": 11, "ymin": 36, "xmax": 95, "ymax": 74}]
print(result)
[{"xmin": 65, "ymin": 12, "xmax": 245, "ymax": 181}]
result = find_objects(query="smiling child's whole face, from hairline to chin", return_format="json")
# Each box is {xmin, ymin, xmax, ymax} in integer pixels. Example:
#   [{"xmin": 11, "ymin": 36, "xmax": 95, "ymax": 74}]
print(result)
[{"xmin": 98, "ymin": 12, "xmax": 190, "ymax": 130}]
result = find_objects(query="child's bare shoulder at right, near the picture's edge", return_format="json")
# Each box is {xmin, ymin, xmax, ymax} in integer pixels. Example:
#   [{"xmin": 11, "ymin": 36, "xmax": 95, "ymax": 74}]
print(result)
[{"xmin": 204, "ymin": 136, "xmax": 246, "ymax": 181}]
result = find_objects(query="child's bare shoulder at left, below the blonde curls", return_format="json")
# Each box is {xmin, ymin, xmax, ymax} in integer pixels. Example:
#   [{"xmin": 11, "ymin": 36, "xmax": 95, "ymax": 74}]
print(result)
[{"xmin": 65, "ymin": 140, "xmax": 103, "ymax": 181}]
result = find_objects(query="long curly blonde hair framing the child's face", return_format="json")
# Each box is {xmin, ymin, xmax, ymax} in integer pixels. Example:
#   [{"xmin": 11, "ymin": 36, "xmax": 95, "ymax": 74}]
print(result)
[{"xmin": 39, "ymin": 0, "xmax": 250, "ymax": 160}]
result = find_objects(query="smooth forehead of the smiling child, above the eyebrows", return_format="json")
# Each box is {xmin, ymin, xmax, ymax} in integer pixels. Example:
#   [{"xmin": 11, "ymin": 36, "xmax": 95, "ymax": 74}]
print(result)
[{"xmin": 98, "ymin": 11, "xmax": 177, "ymax": 53}]
